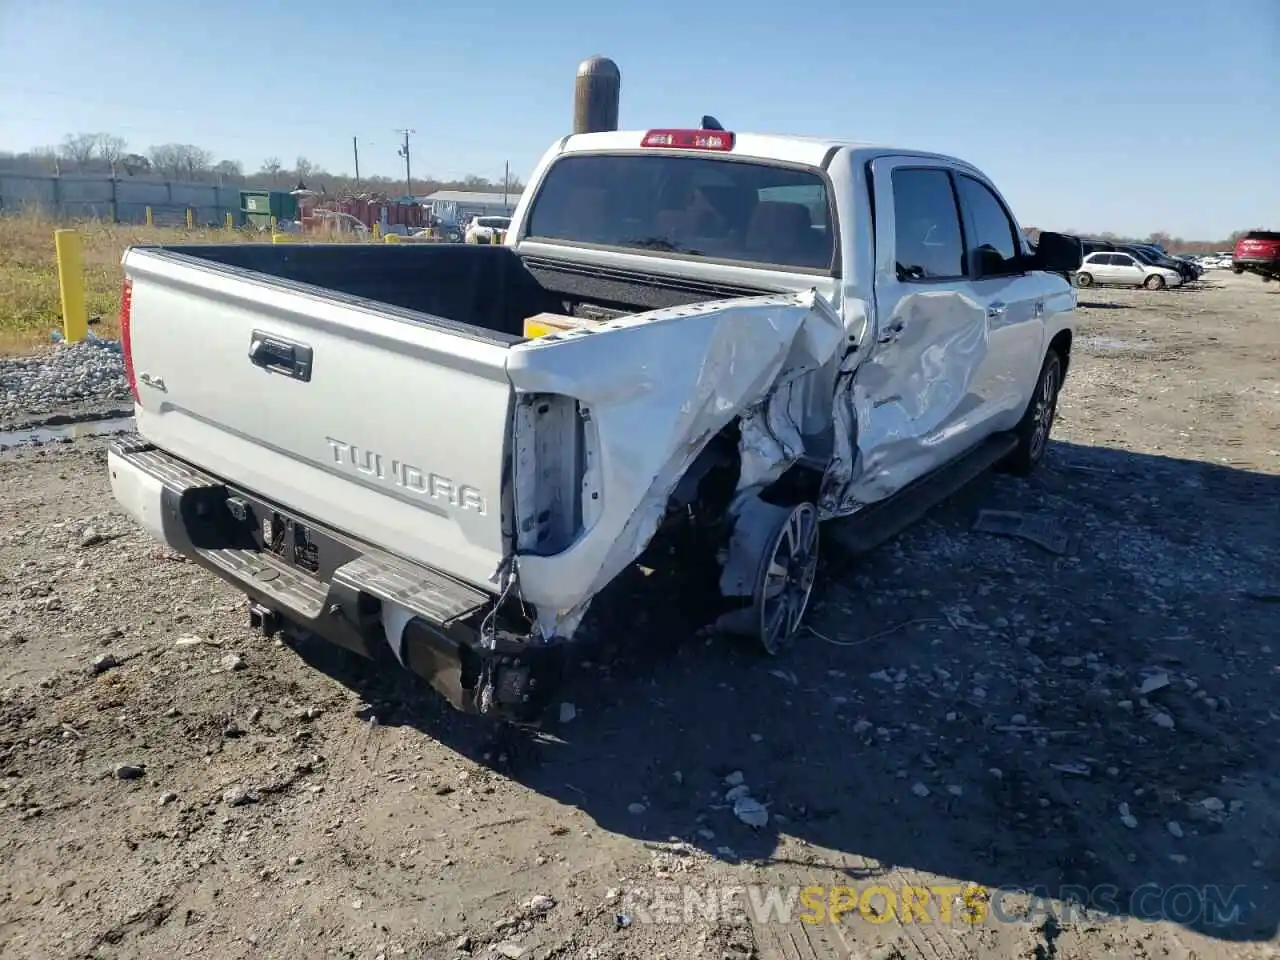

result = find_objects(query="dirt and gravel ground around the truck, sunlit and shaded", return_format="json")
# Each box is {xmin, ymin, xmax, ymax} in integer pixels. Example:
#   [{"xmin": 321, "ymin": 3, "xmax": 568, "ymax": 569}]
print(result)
[{"xmin": 0, "ymin": 274, "xmax": 1280, "ymax": 960}]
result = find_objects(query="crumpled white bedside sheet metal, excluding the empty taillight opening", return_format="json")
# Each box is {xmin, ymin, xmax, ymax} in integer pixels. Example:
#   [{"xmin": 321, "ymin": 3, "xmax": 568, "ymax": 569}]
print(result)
[{"xmin": 507, "ymin": 291, "xmax": 845, "ymax": 637}]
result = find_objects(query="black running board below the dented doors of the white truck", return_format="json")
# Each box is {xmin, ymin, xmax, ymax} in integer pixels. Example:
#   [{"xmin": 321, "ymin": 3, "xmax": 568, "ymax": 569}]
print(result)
[{"xmin": 822, "ymin": 433, "xmax": 1018, "ymax": 557}]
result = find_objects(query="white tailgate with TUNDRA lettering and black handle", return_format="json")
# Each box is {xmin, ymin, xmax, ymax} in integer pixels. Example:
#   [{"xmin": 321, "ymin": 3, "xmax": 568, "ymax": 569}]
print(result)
[{"xmin": 124, "ymin": 250, "xmax": 512, "ymax": 590}]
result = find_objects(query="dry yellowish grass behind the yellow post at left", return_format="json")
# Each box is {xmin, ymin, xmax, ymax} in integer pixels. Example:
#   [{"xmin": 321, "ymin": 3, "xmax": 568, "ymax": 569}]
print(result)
[{"xmin": 0, "ymin": 212, "xmax": 366, "ymax": 356}]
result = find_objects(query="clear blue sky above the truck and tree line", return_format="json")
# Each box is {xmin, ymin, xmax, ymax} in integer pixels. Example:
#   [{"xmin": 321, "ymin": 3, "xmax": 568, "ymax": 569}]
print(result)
[{"xmin": 0, "ymin": 0, "xmax": 1280, "ymax": 238}]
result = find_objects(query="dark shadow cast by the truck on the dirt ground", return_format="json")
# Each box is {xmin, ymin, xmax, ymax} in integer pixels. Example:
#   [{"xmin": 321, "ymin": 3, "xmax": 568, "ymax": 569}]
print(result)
[{"xmin": 288, "ymin": 443, "xmax": 1280, "ymax": 942}]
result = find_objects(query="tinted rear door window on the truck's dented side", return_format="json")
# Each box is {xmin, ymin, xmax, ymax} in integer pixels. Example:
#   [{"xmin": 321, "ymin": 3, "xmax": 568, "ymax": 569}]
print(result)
[{"xmin": 893, "ymin": 168, "xmax": 968, "ymax": 280}]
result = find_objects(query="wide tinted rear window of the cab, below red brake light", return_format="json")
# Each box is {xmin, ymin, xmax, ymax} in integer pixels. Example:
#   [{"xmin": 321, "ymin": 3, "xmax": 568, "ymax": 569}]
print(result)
[{"xmin": 527, "ymin": 154, "xmax": 836, "ymax": 273}]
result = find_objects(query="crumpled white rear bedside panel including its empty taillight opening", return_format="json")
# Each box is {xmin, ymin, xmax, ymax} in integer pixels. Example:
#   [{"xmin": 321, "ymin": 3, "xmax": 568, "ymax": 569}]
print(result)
[{"xmin": 507, "ymin": 291, "xmax": 849, "ymax": 641}]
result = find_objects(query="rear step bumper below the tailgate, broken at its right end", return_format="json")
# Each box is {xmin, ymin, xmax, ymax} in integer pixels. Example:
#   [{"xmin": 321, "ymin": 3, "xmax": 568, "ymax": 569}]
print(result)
[{"xmin": 109, "ymin": 438, "xmax": 563, "ymax": 721}]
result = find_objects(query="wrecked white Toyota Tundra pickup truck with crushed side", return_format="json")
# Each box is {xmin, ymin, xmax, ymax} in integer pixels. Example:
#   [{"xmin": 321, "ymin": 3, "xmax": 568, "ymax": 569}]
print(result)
[{"xmin": 109, "ymin": 129, "xmax": 1080, "ymax": 718}]
